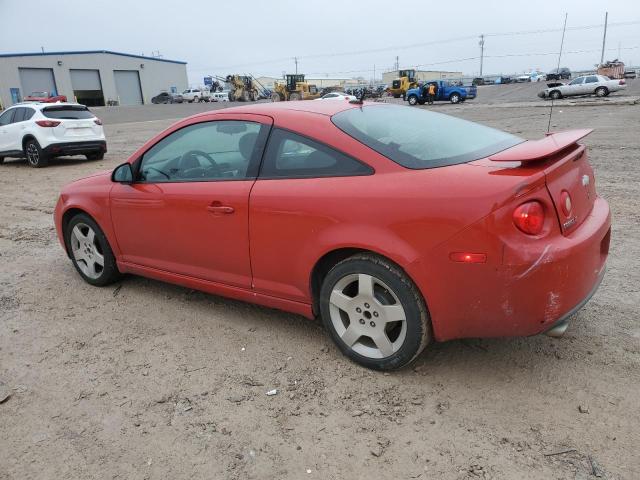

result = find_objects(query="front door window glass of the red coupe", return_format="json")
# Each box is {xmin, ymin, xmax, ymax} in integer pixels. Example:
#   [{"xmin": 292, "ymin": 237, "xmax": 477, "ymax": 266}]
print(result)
[{"xmin": 137, "ymin": 120, "xmax": 263, "ymax": 183}]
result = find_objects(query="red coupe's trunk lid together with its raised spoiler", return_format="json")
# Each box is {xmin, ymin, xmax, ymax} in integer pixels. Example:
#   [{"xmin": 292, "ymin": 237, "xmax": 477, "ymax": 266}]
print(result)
[{"xmin": 489, "ymin": 129, "xmax": 596, "ymax": 235}]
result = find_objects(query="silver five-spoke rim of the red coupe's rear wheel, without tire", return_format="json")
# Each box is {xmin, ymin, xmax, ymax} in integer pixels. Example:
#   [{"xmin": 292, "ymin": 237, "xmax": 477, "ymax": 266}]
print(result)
[{"xmin": 329, "ymin": 273, "xmax": 407, "ymax": 359}]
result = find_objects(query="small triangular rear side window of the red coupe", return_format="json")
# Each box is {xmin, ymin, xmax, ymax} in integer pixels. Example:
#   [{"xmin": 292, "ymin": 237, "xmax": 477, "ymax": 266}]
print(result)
[{"xmin": 260, "ymin": 129, "xmax": 373, "ymax": 178}]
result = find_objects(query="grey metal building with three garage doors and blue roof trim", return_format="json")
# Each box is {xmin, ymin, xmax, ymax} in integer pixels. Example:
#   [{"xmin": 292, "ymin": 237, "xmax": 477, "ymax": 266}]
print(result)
[{"xmin": 0, "ymin": 50, "xmax": 188, "ymax": 107}]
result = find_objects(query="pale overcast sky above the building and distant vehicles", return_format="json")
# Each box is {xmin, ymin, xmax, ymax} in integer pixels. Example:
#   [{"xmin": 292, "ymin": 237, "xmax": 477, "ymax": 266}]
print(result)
[{"xmin": 0, "ymin": 0, "xmax": 640, "ymax": 84}]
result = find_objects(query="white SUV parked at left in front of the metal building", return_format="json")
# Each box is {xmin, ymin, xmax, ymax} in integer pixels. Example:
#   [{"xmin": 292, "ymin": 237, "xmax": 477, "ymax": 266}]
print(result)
[{"xmin": 0, "ymin": 103, "xmax": 107, "ymax": 168}]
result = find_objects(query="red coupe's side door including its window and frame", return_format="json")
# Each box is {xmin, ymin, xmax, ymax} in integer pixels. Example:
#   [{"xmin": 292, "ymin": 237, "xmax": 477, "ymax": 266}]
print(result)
[{"xmin": 110, "ymin": 114, "xmax": 272, "ymax": 288}]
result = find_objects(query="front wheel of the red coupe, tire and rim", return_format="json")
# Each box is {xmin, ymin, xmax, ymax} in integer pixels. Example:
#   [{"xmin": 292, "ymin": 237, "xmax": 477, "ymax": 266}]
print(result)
[{"xmin": 64, "ymin": 213, "xmax": 122, "ymax": 287}]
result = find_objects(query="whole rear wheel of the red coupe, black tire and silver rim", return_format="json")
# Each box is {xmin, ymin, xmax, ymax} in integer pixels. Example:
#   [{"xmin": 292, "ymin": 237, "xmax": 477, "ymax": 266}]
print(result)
[{"xmin": 320, "ymin": 254, "xmax": 431, "ymax": 370}]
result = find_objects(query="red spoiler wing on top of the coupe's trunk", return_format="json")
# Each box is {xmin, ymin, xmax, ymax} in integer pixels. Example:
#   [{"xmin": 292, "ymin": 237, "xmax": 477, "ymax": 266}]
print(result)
[{"xmin": 489, "ymin": 128, "xmax": 593, "ymax": 162}]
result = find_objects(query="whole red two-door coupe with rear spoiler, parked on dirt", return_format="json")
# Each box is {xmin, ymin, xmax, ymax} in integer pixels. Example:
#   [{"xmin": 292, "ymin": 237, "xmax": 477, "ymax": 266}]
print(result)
[{"xmin": 55, "ymin": 101, "xmax": 611, "ymax": 370}]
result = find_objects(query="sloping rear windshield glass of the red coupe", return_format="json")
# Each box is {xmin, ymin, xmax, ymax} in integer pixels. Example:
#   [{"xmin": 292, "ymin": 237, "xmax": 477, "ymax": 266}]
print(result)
[{"xmin": 331, "ymin": 105, "xmax": 524, "ymax": 169}]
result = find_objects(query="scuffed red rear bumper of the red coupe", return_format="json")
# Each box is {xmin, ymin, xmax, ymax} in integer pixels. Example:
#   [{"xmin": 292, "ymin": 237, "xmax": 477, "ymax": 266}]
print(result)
[{"xmin": 418, "ymin": 198, "xmax": 611, "ymax": 340}]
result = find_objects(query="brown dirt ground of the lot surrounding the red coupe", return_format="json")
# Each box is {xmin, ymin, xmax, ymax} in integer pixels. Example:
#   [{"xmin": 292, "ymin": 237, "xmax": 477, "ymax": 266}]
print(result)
[{"xmin": 0, "ymin": 93, "xmax": 640, "ymax": 480}]
